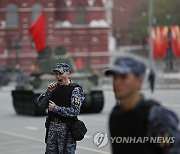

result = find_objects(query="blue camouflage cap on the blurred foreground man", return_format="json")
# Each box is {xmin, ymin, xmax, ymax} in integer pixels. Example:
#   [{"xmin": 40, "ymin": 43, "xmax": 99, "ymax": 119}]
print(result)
[{"xmin": 105, "ymin": 57, "xmax": 146, "ymax": 76}]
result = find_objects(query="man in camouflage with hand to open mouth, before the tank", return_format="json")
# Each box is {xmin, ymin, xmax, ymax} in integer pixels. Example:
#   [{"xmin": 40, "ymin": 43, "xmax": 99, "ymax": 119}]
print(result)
[{"xmin": 37, "ymin": 63, "xmax": 85, "ymax": 154}]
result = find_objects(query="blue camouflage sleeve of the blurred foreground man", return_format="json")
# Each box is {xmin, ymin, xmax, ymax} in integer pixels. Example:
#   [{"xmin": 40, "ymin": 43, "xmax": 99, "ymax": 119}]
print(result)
[{"xmin": 148, "ymin": 105, "xmax": 180, "ymax": 154}]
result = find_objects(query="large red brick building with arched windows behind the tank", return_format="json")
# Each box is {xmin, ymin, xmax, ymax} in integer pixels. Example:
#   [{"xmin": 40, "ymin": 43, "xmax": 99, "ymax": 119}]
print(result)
[{"xmin": 0, "ymin": 0, "xmax": 109, "ymax": 73}]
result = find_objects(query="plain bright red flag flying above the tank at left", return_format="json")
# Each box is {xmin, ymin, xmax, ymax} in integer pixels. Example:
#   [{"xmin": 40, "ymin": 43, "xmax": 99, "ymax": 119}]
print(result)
[{"xmin": 29, "ymin": 12, "xmax": 45, "ymax": 51}]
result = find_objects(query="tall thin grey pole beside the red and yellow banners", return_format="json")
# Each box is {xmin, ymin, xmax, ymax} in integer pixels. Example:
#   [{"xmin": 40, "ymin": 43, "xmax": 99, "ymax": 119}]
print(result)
[{"xmin": 149, "ymin": 0, "xmax": 154, "ymax": 70}]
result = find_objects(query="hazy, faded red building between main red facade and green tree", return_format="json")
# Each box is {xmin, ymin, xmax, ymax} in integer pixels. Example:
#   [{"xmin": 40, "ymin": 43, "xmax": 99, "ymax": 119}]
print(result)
[{"xmin": 112, "ymin": 0, "xmax": 143, "ymax": 47}]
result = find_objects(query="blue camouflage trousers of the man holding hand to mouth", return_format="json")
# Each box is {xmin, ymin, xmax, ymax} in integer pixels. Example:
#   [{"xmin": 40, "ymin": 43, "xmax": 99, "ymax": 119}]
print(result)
[{"xmin": 45, "ymin": 122, "xmax": 76, "ymax": 154}]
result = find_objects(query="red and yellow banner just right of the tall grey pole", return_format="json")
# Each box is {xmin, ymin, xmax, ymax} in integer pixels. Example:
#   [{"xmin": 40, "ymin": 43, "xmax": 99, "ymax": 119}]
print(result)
[{"xmin": 152, "ymin": 26, "xmax": 169, "ymax": 58}]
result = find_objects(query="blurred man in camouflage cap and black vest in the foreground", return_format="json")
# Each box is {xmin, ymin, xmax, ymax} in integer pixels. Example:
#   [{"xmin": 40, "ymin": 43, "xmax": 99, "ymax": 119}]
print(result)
[{"xmin": 105, "ymin": 57, "xmax": 180, "ymax": 154}]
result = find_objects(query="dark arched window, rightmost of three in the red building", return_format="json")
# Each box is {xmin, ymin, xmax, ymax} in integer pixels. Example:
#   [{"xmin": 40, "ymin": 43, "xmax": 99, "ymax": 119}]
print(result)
[{"xmin": 75, "ymin": 3, "xmax": 86, "ymax": 25}]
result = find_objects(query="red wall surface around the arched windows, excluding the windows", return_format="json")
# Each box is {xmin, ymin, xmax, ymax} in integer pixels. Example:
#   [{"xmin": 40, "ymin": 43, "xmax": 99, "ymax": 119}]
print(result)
[{"xmin": 0, "ymin": 0, "xmax": 109, "ymax": 73}]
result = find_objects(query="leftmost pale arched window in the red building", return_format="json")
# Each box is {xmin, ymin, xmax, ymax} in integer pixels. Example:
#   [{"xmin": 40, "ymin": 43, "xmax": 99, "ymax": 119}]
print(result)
[{"xmin": 6, "ymin": 3, "xmax": 19, "ymax": 28}]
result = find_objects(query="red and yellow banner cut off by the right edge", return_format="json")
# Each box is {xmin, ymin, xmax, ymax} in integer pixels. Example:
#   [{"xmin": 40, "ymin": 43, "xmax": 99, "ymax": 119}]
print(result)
[{"xmin": 171, "ymin": 26, "xmax": 180, "ymax": 58}]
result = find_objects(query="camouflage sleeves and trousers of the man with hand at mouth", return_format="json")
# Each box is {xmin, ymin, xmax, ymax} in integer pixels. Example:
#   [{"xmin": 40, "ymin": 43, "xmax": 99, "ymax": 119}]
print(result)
[{"xmin": 37, "ymin": 62, "xmax": 85, "ymax": 154}]
